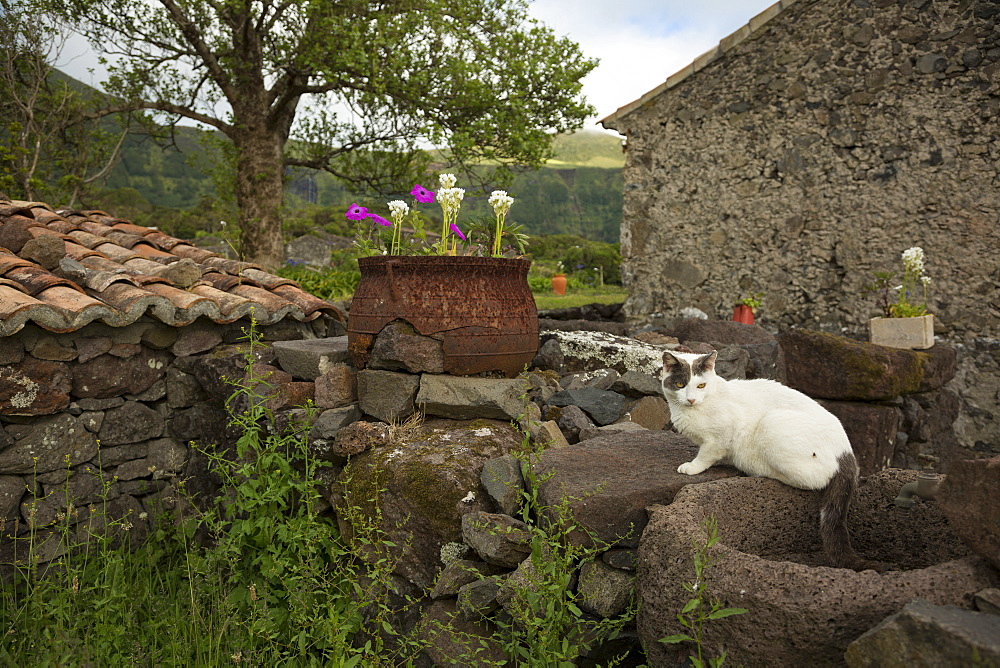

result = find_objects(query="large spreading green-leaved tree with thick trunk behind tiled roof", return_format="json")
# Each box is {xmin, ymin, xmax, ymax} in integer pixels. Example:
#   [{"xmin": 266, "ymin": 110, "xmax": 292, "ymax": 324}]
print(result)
[{"xmin": 45, "ymin": 0, "xmax": 596, "ymax": 266}]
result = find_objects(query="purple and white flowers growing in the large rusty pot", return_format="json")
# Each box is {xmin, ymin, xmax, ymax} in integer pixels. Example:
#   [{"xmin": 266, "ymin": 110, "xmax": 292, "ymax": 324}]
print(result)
[{"xmin": 345, "ymin": 174, "xmax": 528, "ymax": 257}]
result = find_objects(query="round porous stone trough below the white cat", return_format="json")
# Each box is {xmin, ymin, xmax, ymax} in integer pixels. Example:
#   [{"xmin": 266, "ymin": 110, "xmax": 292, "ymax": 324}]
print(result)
[{"xmin": 637, "ymin": 469, "xmax": 1000, "ymax": 666}]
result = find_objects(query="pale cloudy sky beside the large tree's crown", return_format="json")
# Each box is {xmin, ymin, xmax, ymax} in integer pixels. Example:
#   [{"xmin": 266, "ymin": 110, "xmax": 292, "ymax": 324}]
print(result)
[{"xmin": 59, "ymin": 0, "xmax": 776, "ymax": 136}]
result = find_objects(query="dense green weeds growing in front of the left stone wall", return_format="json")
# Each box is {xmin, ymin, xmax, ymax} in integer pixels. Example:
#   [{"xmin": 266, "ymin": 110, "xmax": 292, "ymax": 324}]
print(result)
[{"xmin": 0, "ymin": 322, "xmax": 416, "ymax": 666}]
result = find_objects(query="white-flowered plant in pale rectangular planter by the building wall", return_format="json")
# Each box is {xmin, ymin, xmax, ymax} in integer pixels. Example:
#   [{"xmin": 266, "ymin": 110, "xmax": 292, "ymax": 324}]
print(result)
[{"xmin": 864, "ymin": 246, "xmax": 934, "ymax": 350}]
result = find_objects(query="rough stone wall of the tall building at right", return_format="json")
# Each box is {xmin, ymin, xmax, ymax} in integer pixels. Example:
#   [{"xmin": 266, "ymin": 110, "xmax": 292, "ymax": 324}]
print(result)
[{"xmin": 603, "ymin": 0, "xmax": 1000, "ymax": 449}]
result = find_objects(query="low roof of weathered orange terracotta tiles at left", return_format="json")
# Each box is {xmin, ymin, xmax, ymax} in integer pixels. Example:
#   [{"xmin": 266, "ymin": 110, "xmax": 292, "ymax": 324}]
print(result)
[{"xmin": 0, "ymin": 199, "xmax": 343, "ymax": 336}]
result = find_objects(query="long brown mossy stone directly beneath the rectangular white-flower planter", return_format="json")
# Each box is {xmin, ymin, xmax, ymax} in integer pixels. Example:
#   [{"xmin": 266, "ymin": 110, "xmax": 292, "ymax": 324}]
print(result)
[{"xmin": 778, "ymin": 329, "xmax": 955, "ymax": 401}]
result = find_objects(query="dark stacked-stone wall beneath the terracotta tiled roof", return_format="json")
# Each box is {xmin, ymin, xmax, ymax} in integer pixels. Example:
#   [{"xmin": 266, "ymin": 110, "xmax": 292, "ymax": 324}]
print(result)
[{"xmin": 0, "ymin": 319, "xmax": 326, "ymax": 563}]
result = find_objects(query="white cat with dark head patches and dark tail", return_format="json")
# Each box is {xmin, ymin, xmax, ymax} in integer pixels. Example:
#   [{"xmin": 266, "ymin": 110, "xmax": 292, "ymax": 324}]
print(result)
[{"xmin": 660, "ymin": 352, "xmax": 866, "ymax": 569}]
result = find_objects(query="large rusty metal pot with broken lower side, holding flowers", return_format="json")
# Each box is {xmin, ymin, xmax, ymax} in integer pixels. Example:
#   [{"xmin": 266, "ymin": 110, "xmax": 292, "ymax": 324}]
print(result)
[{"xmin": 347, "ymin": 255, "xmax": 538, "ymax": 378}]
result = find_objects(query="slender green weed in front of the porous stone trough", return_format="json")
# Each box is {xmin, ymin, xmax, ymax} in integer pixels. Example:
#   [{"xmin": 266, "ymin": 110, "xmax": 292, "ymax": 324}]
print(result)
[{"xmin": 660, "ymin": 517, "xmax": 748, "ymax": 668}]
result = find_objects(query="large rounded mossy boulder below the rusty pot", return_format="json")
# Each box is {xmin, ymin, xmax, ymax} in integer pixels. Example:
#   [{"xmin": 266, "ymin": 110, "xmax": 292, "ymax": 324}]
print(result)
[{"xmin": 336, "ymin": 420, "xmax": 524, "ymax": 588}]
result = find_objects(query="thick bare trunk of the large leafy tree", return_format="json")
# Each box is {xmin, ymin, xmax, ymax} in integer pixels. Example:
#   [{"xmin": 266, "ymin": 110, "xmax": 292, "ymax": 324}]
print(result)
[{"xmin": 233, "ymin": 129, "xmax": 285, "ymax": 270}]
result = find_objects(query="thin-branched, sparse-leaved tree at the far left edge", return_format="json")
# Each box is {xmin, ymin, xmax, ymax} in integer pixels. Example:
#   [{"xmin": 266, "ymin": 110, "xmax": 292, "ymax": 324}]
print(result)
[{"xmin": 0, "ymin": 0, "xmax": 126, "ymax": 205}]
